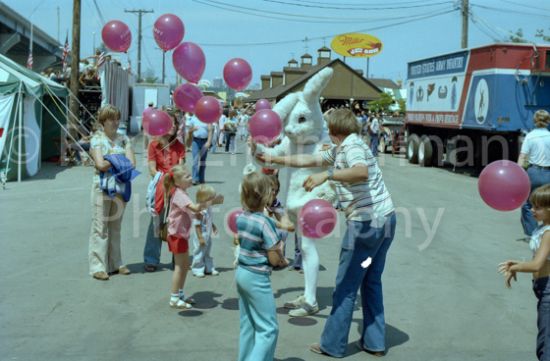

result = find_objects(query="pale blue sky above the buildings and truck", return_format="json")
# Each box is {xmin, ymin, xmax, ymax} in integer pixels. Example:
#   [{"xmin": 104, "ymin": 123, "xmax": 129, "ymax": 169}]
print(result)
[{"xmin": 3, "ymin": 0, "xmax": 550, "ymax": 83}]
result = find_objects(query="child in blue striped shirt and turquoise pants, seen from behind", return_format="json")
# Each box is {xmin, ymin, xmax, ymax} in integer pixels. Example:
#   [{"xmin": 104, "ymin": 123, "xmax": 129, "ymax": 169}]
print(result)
[{"xmin": 235, "ymin": 173, "xmax": 288, "ymax": 361}]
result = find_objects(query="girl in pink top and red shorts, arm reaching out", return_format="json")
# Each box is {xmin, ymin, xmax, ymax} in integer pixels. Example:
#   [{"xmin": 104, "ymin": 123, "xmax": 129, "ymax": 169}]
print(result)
[{"xmin": 163, "ymin": 165, "xmax": 223, "ymax": 309}]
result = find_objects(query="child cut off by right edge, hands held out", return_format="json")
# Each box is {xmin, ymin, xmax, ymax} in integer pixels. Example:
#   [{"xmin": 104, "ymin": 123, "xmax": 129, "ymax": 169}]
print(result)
[{"xmin": 498, "ymin": 184, "xmax": 550, "ymax": 360}]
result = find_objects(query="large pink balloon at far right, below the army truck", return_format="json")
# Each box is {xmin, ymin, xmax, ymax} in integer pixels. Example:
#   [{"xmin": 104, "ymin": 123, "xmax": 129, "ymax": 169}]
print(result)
[{"xmin": 477, "ymin": 160, "xmax": 531, "ymax": 211}]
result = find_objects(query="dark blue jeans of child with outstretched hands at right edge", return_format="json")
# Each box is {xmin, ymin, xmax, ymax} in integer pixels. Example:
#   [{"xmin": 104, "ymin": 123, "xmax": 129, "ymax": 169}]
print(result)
[{"xmin": 533, "ymin": 277, "xmax": 550, "ymax": 361}]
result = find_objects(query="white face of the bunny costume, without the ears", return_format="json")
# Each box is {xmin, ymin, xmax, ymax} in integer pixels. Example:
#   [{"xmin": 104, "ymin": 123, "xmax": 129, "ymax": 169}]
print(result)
[{"xmin": 284, "ymin": 97, "xmax": 324, "ymax": 144}]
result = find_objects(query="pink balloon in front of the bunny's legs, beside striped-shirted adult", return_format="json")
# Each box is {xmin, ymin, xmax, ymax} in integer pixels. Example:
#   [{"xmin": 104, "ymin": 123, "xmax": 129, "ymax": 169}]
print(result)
[{"xmin": 298, "ymin": 199, "xmax": 338, "ymax": 238}]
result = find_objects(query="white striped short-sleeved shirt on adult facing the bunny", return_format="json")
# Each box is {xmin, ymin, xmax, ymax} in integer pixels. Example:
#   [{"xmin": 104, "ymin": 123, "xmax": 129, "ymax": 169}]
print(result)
[{"xmin": 321, "ymin": 133, "xmax": 394, "ymax": 221}]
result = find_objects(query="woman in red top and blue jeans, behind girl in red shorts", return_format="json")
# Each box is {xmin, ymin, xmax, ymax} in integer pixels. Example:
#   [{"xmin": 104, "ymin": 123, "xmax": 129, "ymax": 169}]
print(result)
[{"xmin": 143, "ymin": 114, "xmax": 185, "ymax": 272}]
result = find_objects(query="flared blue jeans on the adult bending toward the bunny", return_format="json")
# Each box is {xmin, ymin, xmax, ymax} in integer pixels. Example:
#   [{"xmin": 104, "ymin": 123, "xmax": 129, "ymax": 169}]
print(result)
[{"xmin": 321, "ymin": 213, "xmax": 396, "ymax": 357}]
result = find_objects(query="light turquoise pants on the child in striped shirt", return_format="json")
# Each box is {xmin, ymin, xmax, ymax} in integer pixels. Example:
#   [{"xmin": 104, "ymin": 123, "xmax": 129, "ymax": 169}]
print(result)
[{"xmin": 235, "ymin": 266, "xmax": 279, "ymax": 361}]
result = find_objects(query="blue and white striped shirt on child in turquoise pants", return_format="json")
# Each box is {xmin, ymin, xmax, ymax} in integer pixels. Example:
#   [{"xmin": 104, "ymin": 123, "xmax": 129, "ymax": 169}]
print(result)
[{"xmin": 237, "ymin": 212, "xmax": 278, "ymax": 274}]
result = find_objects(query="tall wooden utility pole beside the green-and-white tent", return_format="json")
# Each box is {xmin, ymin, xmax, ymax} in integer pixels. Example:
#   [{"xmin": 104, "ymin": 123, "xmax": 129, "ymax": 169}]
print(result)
[{"xmin": 69, "ymin": 0, "xmax": 81, "ymax": 136}]
